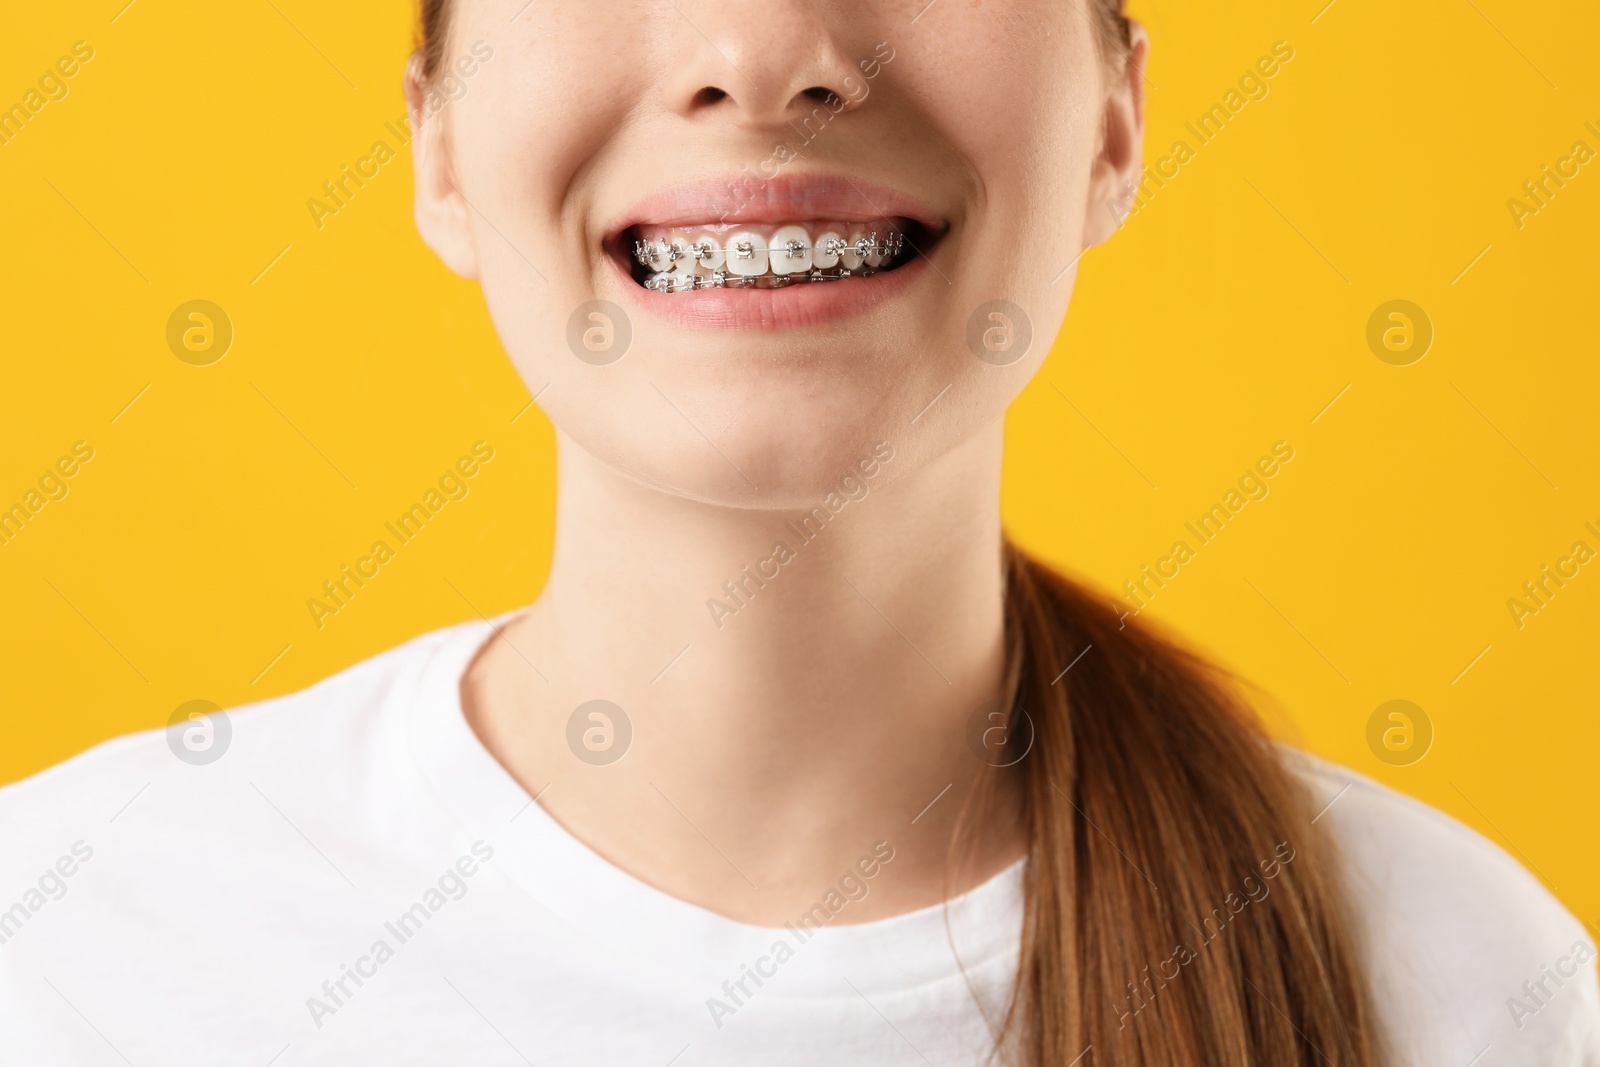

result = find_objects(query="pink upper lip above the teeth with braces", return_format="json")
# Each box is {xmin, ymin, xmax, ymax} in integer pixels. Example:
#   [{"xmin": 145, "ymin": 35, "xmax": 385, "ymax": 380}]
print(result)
[{"xmin": 605, "ymin": 173, "xmax": 944, "ymax": 238}]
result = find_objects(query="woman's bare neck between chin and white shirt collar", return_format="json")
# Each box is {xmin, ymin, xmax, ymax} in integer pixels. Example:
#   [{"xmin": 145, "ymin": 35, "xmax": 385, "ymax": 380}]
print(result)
[{"xmin": 462, "ymin": 424, "xmax": 1021, "ymax": 925}]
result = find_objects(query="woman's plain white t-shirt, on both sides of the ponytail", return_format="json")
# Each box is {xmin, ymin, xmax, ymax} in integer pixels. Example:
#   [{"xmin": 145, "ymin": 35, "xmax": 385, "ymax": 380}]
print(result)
[{"xmin": 0, "ymin": 624, "xmax": 1600, "ymax": 1067}]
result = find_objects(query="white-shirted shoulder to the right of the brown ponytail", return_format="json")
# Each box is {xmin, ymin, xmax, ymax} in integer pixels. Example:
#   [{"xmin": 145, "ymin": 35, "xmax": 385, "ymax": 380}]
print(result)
[{"xmin": 1290, "ymin": 753, "xmax": 1600, "ymax": 1067}]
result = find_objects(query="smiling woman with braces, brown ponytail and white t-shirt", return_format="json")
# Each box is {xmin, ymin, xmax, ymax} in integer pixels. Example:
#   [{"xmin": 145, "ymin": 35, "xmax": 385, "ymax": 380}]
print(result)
[{"xmin": 0, "ymin": 0, "xmax": 1600, "ymax": 1067}]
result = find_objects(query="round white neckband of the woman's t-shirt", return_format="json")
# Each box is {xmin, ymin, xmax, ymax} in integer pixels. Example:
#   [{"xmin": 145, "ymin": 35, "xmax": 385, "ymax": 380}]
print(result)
[{"xmin": 397, "ymin": 616, "xmax": 1024, "ymax": 998}]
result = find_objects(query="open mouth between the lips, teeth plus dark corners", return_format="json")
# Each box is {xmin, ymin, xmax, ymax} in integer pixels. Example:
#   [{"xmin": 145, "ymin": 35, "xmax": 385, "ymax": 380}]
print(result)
[{"xmin": 619, "ymin": 216, "xmax": 931, "ymax": 293}]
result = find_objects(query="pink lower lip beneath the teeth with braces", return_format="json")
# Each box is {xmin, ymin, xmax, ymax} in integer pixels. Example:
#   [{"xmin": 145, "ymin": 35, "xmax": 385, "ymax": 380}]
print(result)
[{"xmin": 613, "ymin": 256, "xmax": 928, "ymax": 330}]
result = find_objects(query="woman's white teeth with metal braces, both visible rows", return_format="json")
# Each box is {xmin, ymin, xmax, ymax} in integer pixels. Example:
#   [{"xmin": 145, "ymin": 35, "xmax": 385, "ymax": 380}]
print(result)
[{"xmin": 634, "ymin": 219, "xmax": 904, "ymax": 291}]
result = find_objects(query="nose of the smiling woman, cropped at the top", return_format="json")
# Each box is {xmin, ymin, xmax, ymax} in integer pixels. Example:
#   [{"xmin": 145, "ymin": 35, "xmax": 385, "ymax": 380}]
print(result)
[{"xmin": 666, "ymin": 0, "xmax": 870, "ymax": 130}]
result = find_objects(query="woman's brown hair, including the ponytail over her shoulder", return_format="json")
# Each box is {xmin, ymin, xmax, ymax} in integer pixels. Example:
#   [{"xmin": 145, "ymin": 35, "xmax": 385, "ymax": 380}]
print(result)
[{"xmin": 418, "ymin": 0, "xmax": 1387, "ymax": 1067}]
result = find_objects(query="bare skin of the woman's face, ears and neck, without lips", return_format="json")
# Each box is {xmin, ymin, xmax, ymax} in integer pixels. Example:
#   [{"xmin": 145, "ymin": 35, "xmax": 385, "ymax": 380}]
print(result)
[{"xmin": 406, "ymin": 0, "xmax": 1147, "ymax": 925}]
